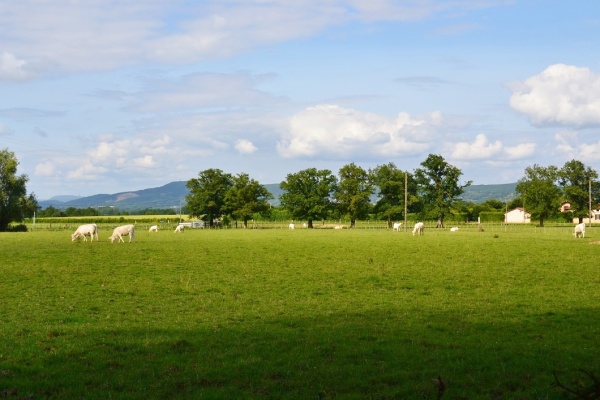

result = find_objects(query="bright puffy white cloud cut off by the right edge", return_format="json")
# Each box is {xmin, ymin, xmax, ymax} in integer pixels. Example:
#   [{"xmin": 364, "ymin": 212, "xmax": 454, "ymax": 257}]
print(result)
[{"xmin": 510, "ymin": 64, "xmax": 600, "ymax": 127}]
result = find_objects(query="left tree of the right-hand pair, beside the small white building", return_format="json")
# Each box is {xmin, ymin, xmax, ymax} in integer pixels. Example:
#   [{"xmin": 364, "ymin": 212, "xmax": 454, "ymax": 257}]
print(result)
[{"xmin": 517, "ymin": 164, "xmax": 561, "ymax": 226}]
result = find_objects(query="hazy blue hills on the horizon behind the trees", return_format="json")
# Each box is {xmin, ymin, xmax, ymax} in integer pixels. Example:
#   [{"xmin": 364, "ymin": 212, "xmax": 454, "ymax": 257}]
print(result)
[{"xmin": 38, "ymin": 181, "xmax": 517, "ymax": 211}]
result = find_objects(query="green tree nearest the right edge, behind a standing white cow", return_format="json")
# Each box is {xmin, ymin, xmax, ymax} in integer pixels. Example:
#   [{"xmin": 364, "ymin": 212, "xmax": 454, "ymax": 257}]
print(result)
[{"xmin": 558, "ymin": 160, "xmax": 598, "ymax": 223}]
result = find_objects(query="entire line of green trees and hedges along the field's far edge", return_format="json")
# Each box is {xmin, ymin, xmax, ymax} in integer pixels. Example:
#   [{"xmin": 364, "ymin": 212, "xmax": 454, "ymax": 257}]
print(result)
[{"xmin": 0, "ymin": 149, "xmax": 600, "ymax": 231}]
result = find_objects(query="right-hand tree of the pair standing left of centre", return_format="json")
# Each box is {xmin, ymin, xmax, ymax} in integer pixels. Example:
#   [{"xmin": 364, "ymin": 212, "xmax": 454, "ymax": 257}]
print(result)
[{"xmin": 224, "ymin": 173, "xmax": 273, "ymax": 228}]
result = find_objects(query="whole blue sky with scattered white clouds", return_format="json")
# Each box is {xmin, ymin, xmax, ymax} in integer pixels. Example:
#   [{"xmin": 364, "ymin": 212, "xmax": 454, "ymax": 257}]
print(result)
[{"xmin": 0, "ymin": 0, "xmax": 600, "ymax": 199}]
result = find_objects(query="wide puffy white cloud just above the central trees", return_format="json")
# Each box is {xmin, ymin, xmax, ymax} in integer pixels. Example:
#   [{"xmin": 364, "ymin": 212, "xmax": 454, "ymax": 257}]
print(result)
[{"xmin": 277, "ymin": 105, "xmax": 440, "ymax": 158}]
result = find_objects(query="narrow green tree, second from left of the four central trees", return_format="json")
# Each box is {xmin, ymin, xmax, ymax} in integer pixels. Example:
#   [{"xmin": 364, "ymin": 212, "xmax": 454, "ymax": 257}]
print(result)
[{"xmin": 335, "ymin": 163, "xmax": 374, "ymax": 228}]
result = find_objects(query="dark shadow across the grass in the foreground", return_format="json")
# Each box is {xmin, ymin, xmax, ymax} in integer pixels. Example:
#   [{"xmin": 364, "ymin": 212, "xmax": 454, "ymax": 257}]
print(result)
[{"xmin": 0, "ymin": 308, "xmax": 600, "ymax": 399}]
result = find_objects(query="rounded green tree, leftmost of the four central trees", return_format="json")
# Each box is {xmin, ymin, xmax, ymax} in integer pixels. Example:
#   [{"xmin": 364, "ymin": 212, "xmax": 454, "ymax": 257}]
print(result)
[{"xmin": 279, "ymin": 168, "xmax": 338, "ymax": 228}]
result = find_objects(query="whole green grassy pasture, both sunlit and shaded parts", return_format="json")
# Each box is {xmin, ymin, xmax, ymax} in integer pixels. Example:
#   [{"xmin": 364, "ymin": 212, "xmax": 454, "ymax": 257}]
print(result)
[{"xmin": 0, "ymin": 223, "xmax": 600, "ymax": 399}]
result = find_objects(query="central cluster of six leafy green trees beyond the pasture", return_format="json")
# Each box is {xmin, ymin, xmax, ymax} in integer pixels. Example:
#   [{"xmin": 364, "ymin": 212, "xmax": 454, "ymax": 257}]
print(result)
[{"xmin": 186, "ymin": 154, "xmax": 471, "ymax": 228}]
